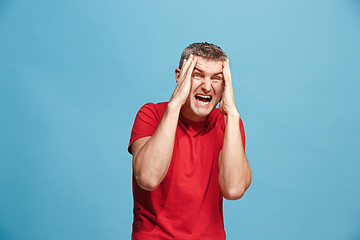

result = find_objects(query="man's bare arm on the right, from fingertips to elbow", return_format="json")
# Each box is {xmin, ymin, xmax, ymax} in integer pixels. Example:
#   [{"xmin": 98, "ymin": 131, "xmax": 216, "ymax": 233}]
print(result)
[{"xmin": 218, "ymin": 60, "xmax": 251, "ymax": 200}]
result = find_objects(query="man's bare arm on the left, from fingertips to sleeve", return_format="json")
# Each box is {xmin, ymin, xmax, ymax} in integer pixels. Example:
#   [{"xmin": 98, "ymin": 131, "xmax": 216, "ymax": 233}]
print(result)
[{"xmin": 131, "ymin": 55, "xmax": 196, "ymax": 191}]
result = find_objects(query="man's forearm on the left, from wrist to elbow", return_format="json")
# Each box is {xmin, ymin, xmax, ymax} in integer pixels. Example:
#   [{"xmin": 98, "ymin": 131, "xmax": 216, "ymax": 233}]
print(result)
[{"xmin": 133, "ymin": 103, "xmax": 180, "ymax": 191}]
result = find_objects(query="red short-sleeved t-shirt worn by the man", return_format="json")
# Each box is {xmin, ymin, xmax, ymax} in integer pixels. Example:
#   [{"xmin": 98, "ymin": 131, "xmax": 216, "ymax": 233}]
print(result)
[{"xmin": 128, "ymin": 103, "xmax": 245, "ymax": 240}]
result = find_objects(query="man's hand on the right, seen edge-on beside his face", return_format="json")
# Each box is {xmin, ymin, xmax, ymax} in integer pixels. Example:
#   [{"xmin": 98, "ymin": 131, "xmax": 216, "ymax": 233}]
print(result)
[{"xmin": 219, "ymin": 59, "xmax": 239, "ymax": 117}]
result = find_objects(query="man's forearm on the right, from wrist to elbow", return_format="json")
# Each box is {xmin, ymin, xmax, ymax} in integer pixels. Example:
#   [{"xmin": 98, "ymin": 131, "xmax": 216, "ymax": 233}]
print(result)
[{"xmin": 219, "ymin": 113, "xmax": 251, "ymax": 200}]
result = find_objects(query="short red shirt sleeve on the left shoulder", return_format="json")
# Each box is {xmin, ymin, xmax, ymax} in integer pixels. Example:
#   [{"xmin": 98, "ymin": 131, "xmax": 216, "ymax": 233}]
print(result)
[{"xmin": 128, "ymin": 103, "xmax": 161, "ymax": 154}]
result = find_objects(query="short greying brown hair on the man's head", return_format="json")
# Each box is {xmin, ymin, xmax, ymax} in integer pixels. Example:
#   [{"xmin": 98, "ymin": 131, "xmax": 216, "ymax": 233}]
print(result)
[{"xmin": 179, "ymin": 42, "xmax": 227, "ymax": 68}]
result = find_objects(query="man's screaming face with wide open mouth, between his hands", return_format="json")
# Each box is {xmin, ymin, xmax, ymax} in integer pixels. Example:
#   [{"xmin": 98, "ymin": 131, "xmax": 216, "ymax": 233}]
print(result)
[{"xmin": 177, "ymin": 56, "xmax": 224, "ymax": 122}]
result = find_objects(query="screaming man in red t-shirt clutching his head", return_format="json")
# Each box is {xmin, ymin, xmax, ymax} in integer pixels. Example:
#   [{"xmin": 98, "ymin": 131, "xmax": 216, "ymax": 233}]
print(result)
[{"xmin": 128, "ymin": 43, "xmax": 251, "ymax": 240}]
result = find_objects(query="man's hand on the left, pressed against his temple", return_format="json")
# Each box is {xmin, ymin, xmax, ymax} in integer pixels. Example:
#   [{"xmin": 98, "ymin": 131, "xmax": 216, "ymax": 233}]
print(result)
[{"xmin": 169, "ymin": 54, "xmax": 197, "ymax": 108}]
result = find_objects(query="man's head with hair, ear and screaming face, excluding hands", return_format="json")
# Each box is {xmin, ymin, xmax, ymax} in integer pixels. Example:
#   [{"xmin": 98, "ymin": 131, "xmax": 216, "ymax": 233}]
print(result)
[{"xmin": 175, "ymin": 43, "xmax": 227, "ymax": 121}]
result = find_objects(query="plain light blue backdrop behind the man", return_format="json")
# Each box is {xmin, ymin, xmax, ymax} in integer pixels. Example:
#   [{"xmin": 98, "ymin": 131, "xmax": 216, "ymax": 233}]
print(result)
[{"xmin": 0, "ymin": 0, "xmax": 360, "ymax": 240}]
